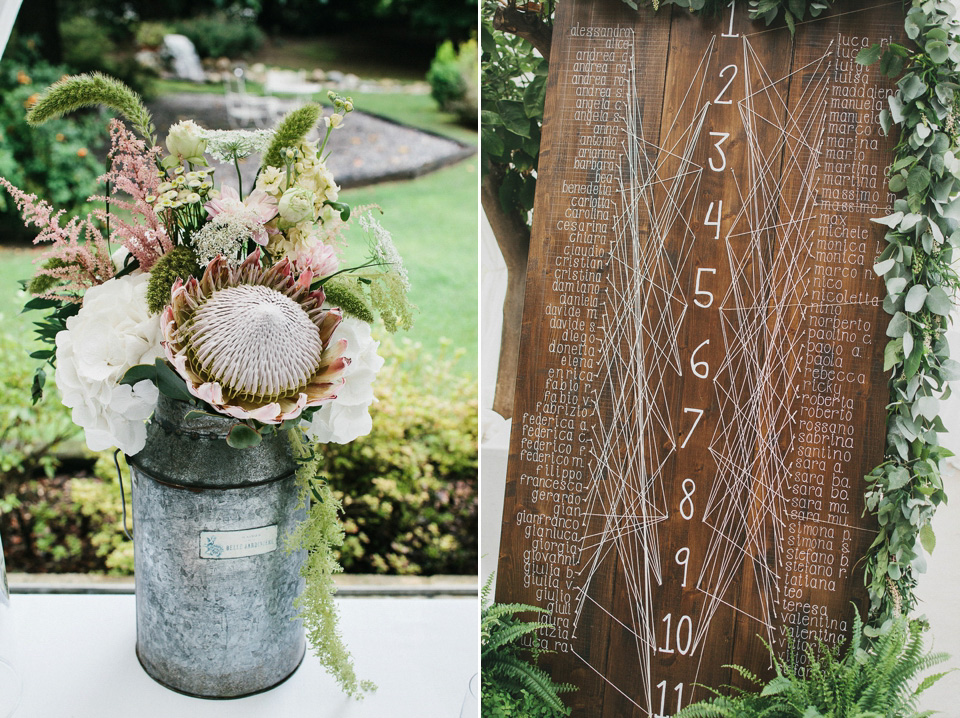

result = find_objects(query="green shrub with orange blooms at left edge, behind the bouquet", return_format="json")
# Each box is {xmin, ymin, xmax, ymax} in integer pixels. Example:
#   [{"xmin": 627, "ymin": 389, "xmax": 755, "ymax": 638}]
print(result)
[{"xmin": 0, "ymin": 40, "xmax": 107, "ymax": 243}]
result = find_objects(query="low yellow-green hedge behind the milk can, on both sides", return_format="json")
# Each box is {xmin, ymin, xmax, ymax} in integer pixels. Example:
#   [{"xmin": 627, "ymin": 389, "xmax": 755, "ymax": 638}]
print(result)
[{"xmin": 0, "ymin": 330, "xmax": 477, "ymax": 574}]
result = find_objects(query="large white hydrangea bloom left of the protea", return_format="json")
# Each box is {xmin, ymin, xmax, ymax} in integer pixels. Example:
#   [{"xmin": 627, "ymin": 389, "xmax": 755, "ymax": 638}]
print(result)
[{"xmin": 56, "ymin": 273, "xmax": 163, "ymax": 455}]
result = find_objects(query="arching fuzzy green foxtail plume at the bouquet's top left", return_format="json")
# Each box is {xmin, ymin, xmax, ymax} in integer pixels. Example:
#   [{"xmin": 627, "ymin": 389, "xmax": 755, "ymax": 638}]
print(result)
[{"xmin": 27, "ymin": 72, "xmax": 156, "ymax": 146}]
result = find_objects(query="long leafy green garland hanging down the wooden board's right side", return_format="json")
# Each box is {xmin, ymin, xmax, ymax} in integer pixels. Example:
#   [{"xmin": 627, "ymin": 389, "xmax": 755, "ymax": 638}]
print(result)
[{"xmin": 857, "ymin": 0, "xmax": 960, "ymax": 624}]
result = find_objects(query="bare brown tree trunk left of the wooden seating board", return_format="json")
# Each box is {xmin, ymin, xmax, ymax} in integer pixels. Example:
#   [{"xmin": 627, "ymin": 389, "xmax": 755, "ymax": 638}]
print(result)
[{"xmin": 480, "ymin": 164, "xmax": 530, "ymax": 419}]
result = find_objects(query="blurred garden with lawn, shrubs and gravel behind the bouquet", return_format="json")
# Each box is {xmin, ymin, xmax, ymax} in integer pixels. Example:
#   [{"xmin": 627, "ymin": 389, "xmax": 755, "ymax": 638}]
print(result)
[{"xmin": 0, "ymin": 0, "xmax": 478, "ymax": 575}]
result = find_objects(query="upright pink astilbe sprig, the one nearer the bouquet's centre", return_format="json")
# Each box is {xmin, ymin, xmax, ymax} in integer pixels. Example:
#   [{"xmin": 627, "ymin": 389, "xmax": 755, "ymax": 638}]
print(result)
[{"xmin": 91, "ymin": 119, "xmax": 174, "ymax": 272}]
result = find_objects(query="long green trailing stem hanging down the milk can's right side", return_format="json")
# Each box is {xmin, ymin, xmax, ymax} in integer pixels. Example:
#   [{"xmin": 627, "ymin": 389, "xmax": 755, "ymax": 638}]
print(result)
[{"xmin": 286, "ymin": 428, "xmax": 376, "ymax": 699}]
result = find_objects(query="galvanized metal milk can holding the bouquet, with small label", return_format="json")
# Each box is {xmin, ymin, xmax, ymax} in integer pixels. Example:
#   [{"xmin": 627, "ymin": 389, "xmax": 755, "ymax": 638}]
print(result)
[{"xmin": 128, "ymin": 395, "xmax": 305, "ymax": 698}]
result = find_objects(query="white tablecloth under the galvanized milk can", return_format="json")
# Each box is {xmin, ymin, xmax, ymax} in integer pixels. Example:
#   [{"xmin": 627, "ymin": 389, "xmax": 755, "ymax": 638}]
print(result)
[{"xmin": 3, "ymin": 594, "xmax": 479, "ymax": 718}]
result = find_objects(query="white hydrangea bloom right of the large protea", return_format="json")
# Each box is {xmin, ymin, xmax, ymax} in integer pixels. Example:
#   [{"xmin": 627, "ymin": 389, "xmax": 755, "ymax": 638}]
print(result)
[{"xmin": 303, "ymin": 317, "xmax": 383, "ymax": 444}]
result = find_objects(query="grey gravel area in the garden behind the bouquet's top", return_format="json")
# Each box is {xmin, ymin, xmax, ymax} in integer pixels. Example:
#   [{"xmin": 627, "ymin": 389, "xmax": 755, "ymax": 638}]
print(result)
[{"xmin": 149, "ymin": 93, "xmax": 476, "ymax": 188}]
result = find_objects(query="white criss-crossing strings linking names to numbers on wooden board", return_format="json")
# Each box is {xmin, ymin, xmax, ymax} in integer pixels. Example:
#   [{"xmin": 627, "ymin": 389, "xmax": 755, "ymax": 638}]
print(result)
[{"xmin": 572, "ymin": 37, "xmax": 848, "ymax": 715}]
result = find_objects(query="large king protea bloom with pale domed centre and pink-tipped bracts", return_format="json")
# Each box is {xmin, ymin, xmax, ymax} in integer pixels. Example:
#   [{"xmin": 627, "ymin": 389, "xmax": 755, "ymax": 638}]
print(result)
[{"xmin": 161, "ymin": 249, "xmax": 350, "ymax": 424}]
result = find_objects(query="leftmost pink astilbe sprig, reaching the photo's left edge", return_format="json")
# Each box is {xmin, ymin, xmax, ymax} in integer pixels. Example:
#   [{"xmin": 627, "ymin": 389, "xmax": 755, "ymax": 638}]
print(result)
[{"xmin": 0, "ymin": 177, "xmax": 114, "ymax": 302}]
